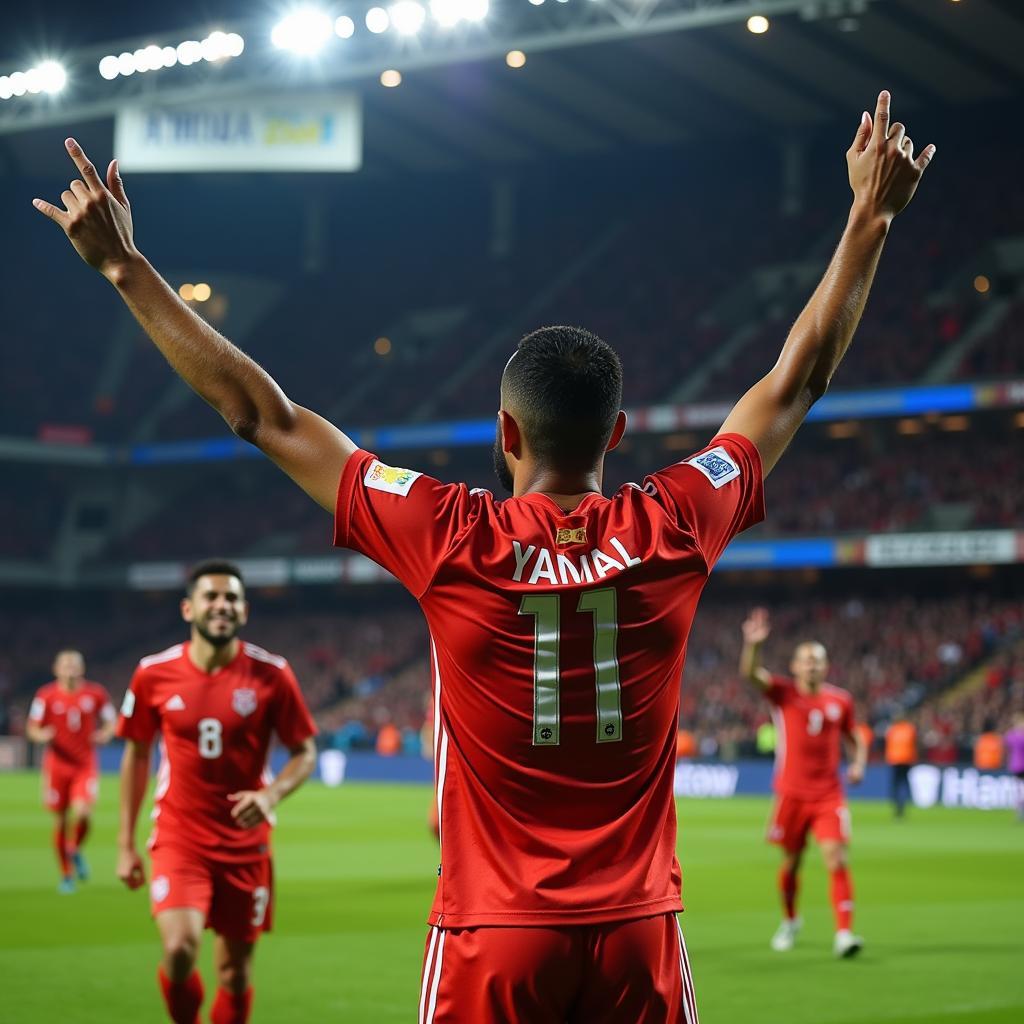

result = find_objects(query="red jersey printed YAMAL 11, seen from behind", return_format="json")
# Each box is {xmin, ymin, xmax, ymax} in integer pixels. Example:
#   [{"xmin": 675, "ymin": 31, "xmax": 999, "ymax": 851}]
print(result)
[{"xmin": 335, "ymin": 434, "xmax": 764, "ymax": 928}]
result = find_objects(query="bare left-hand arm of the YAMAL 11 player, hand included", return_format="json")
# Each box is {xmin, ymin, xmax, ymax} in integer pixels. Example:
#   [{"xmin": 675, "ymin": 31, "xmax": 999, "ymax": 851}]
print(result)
[{"xmin": 33, "ymin": 138, "xmax": 355, "ymax": 511}]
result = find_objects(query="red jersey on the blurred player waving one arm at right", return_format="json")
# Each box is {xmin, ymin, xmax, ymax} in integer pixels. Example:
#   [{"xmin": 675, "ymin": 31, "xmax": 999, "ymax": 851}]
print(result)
[{"xmin": 766, "ymin": 676, "xmax": 854, "ymax": 800}]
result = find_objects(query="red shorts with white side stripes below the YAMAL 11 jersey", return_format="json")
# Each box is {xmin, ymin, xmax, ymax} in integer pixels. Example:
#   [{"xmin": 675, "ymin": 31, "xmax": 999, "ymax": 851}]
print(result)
[{"xmin": 417, "ymin": 913, "xmax": 697, "ymax": 1024}]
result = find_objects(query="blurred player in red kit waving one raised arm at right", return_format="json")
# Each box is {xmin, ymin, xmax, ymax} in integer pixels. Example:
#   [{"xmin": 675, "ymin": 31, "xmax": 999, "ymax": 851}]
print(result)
[{"xmin": 739, "ymin": 608, "xmax": 867, "ymax": 957}]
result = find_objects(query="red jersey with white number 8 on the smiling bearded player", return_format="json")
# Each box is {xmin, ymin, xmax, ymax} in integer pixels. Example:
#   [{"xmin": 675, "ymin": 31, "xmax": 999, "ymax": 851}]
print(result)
[{"xmin": 117, "ymin": 643, "xmax": 316, "ymax": 860}]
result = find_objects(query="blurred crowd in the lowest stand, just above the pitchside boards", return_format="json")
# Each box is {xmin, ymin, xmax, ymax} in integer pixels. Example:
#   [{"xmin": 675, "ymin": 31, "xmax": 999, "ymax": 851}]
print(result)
[{"xmin": 0, "ymin": 592, "xmax": 1024, "ymax": 761}]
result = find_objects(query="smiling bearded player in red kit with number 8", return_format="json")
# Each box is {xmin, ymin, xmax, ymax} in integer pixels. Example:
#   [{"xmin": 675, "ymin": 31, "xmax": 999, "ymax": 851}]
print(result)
[{"xmin": 118, "ymin": 561, "xmax": 316, "ymax": 1024}]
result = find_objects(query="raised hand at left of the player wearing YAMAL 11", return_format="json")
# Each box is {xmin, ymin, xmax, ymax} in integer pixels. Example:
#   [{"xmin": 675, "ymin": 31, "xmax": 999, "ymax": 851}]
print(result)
[{"xmin": 32, "ymin": 138, "xmax": 138, "ymax": 281}]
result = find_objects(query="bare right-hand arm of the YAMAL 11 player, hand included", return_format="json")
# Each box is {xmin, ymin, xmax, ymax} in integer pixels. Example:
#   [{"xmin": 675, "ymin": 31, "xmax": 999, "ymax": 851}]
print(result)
[{"xmin": 721, "ymin": 92, "xmax": 935, "ymax": 476}]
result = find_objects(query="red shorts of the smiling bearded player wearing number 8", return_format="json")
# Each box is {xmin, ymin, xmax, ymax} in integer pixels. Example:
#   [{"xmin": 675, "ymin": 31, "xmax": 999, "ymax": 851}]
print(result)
[{"xmin": 150, "ymin": 844, "xmax": 273, "ymax": 942}]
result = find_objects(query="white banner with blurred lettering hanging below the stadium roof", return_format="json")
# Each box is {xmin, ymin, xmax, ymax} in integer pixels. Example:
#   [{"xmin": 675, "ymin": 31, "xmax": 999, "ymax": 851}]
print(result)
[{"xmin": 114, "ymin": 93, "xmax": 362, "ymax": 172}]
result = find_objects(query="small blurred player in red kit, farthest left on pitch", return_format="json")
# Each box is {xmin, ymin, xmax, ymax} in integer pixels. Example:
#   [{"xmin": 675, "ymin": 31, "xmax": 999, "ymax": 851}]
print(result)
[{"xmin": 25, "ymin": 650, "xmax": 117, "ymax": 894}]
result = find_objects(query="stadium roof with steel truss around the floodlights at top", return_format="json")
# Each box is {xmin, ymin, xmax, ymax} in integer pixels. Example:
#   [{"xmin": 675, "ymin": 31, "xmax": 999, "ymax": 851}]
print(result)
[{"xmin": 0, "ymin": 0, "xmax": 1024, "ymax": 170}]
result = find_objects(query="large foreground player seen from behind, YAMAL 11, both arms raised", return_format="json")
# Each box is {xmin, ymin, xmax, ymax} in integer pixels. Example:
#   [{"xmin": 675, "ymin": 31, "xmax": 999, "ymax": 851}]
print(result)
[{"xmin": 36, "ymin": 92, "xmax": 934, "ymax": 1024}]
